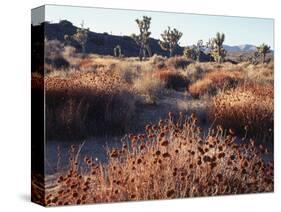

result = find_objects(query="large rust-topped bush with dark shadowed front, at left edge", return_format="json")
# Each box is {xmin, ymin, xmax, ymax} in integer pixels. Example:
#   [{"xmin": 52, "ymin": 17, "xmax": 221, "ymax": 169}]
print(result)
[{"xmin": 45, "ymin": 69, "xmax": 134, "ymax": 139}]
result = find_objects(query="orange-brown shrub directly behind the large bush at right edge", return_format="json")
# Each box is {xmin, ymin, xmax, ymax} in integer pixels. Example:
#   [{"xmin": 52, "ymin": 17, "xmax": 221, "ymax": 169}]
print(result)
[{"xmin": 188, "ymin": 70, "xmax": 243, "ymax": 98}]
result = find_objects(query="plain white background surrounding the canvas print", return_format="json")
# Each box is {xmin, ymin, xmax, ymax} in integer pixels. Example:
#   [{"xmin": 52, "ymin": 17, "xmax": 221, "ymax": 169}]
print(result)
[{"xmin": 0, "ymin": 0, "xmax": 281, "ymax": 212}]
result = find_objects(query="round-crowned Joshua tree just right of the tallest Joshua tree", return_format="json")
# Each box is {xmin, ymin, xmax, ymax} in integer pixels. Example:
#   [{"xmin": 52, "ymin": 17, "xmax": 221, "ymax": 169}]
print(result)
[{"xmin": 159, "ymin": 27, "xmax": 182, "ymax": 57}]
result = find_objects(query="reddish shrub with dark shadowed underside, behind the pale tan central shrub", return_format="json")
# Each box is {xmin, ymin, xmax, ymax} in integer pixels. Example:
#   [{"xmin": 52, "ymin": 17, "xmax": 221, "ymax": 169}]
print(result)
[{"xmin": 153, "ymin": 70, "xmax": 189, "ymax": 90}]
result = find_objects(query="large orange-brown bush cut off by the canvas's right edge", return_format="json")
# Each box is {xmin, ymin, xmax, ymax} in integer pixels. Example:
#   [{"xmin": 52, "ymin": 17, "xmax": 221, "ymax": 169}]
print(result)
[{"xmin": 208, "ymin": 83, "xmax": 274, "ymax": 140}]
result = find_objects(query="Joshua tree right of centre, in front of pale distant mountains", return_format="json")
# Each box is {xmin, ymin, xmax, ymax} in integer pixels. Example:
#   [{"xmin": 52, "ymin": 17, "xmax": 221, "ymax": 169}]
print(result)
[{"xmin": 207, "ymin": 32, "xmax": 226, "ymax": 63}]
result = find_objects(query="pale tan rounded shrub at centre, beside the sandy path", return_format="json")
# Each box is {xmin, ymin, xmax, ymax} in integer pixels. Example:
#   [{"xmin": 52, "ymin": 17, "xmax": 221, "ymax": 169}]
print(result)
[{"xmin": 133, "ymin": 72, "xmax": 165, "ymax": 103}]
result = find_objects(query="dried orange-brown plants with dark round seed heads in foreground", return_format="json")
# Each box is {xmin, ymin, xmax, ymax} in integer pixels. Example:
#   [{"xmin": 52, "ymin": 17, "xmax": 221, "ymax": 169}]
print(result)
[{"xmin": 41, "ymin": 113, "xmax": 273, "ymax": 206}]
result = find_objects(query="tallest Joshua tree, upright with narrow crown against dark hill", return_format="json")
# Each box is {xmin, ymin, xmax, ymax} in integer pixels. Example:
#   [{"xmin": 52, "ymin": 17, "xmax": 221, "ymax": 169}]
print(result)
[{"xmin": 132, "ymin": 16, "xmax": 151, "ymax": 61}]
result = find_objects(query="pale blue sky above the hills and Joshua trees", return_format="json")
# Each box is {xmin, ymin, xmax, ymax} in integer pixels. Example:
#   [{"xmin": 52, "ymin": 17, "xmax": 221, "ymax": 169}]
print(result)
[{"xmin": 40, "ymin": 5, "xmax": 274, "ymax": 48}]
